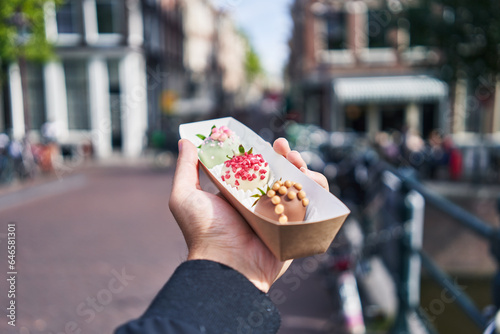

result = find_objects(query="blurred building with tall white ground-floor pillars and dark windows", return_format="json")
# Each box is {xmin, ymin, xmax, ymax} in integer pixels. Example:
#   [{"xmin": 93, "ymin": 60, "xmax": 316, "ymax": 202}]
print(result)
[{"xmin": 0, "ymin": 0, "xmax": 148, "ymax": 157}]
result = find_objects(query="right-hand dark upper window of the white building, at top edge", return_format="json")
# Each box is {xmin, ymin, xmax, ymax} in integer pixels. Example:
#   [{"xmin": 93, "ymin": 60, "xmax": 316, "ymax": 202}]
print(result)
[{"xmin": 96, "ymin": 0, "xmax": 124, "ymax": 34}]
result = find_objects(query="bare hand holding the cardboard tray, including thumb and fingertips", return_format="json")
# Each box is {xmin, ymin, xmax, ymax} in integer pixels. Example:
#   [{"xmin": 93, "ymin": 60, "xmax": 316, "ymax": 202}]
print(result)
[{"xmin": 169, "ymin": 138, "xmax": 328, "ymax": 292}]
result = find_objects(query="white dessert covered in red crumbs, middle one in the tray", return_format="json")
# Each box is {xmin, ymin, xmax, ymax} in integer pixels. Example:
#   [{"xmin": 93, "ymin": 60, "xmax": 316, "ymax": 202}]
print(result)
[{"xmin": 221, "ymin": 152, "xmax": 270, "ymax": 191}]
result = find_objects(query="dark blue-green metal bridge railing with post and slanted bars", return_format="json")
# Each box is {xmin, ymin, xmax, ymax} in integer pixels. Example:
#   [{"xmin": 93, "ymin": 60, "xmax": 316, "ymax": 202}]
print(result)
[{"xmin": 380, "ymin": 162, "xmax": 500, "ymax": 334}]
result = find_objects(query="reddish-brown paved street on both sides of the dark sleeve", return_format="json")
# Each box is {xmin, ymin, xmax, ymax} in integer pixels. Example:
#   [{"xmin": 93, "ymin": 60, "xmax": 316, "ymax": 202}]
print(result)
[{"xmin": 0, "ymin": 161, "xmax": 333, "ymax": 334}]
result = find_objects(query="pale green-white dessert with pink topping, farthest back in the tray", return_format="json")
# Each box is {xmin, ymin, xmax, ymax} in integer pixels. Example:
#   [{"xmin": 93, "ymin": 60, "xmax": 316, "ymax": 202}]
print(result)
[{"xmin": 198, "ymin": 125, "xmax": 240, "ymax": 168}]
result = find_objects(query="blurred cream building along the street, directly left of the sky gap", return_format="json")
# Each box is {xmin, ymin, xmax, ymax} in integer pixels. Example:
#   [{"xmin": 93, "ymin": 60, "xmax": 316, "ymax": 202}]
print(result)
[{"xmin": 173, "ymin": 0, "xmax": 246, "ymax": 116}]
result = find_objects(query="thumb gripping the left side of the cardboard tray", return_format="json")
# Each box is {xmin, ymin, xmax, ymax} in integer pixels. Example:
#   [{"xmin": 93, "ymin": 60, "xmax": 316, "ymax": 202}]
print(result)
[{"xmin": 172, "ymin": 139, "xmax": 200, "ymax": 194}]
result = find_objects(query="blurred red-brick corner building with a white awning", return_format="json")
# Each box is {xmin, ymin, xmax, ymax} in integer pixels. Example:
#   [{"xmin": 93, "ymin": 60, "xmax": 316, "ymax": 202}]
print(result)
[{"xmin": 287, "ymin": 0, "xmax": 472, "ymax": 137}]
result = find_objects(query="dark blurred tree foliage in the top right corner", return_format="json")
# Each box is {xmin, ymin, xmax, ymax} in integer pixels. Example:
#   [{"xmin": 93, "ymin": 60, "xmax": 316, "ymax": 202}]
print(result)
[{"xmin": 408, "ymin": 0, "xmax": 500, "ymax": 80}]
